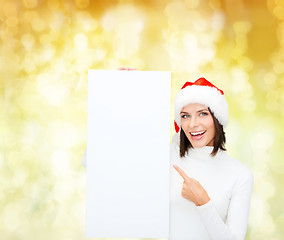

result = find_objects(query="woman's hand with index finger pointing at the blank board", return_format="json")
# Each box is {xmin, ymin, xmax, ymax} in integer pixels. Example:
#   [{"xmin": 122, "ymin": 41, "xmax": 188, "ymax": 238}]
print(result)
[{"xmin": 174, "ymin": 165, "xmax": 210, "ymax": 206}]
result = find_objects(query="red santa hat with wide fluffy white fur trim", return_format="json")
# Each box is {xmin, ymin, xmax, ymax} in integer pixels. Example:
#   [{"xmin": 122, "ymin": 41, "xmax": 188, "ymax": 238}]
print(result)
[{"xmin": 174, "ymin": 78, "xmax": 229, "ymax": 132}]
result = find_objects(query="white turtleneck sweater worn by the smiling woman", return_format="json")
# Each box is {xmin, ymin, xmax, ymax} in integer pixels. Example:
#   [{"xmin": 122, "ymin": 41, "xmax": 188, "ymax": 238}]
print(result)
[{"xmin": 82, "ymin": 134, "xmax": 253, "ymax": 240}]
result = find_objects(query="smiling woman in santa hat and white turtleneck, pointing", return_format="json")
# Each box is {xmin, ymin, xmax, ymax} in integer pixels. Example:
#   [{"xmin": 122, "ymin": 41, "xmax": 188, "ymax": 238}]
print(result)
[{"xmin": 169, "ymin": 78, "xmax": 253, "ymax": 240}]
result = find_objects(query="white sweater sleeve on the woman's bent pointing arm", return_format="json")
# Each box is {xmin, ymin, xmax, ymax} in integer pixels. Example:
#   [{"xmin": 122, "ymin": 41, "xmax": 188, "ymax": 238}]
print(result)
[{"xmin": 197, "ymin": 168, "xmax": 253, "ymax": 240}]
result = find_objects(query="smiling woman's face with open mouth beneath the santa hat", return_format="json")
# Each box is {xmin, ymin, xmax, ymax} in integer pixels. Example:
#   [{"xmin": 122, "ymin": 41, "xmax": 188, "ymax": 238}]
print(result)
[{"xmin": 180, "ymin": 103, "xmax": 215, "ymax": 148}]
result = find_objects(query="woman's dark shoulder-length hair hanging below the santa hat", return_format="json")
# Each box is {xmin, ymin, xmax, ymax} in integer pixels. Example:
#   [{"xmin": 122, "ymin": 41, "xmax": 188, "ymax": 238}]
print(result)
[{"xmin": 179, "ymin": 108, "xmax": 226, "ymax": 157}]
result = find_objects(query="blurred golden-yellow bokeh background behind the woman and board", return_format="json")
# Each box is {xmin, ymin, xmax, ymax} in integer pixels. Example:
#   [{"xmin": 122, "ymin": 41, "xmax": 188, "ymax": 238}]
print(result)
[{"xmin": 0, "ymin": 0, "xmax": 284, "ymax": 240}]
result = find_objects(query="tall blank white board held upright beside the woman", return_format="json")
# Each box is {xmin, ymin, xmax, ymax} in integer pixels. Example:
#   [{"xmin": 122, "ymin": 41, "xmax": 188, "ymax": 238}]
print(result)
[{"xmin": 86, "ymin": 70, "xmax": 171, "ymax": 238}]
